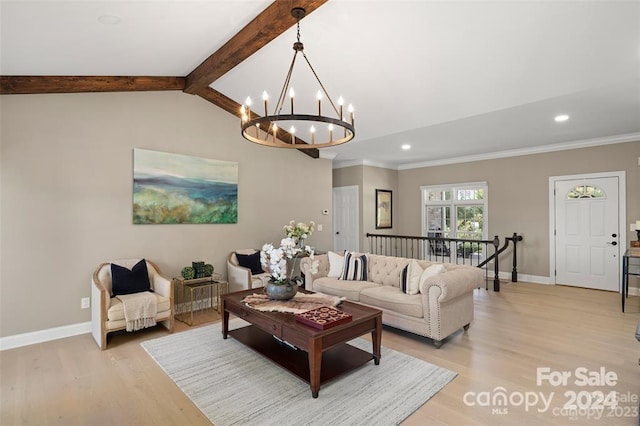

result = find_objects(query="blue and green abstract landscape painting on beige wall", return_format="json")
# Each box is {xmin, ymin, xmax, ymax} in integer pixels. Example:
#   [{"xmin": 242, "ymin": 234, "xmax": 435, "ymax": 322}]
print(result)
[{"xmin": 133, "ymin": 149, "xmax": 238, "ymax": 224}]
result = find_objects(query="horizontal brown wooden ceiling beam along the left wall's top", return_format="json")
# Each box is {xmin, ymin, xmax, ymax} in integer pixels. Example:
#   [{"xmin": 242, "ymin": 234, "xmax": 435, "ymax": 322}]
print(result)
[{"xmin": 0, "ymin": 76, "xmax": 186, "ymax": 95}]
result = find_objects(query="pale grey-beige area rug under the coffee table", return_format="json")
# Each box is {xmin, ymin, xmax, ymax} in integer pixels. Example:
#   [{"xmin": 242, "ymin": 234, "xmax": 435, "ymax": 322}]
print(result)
[{"xmin": 141, "ymin": 319, "xmax": 456, "ymax": 426}]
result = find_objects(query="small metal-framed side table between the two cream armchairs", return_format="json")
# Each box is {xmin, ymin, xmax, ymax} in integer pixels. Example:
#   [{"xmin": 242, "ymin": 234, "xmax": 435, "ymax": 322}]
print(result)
[{"xmin": 173, "ymin": 274, "xmax": 229, "ymax": 326}]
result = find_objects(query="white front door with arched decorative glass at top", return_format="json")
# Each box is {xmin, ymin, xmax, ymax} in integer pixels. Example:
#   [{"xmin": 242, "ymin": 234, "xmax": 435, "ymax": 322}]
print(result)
[{"xmin": 554, "ymin": 177, "xmax": 620, "ymax": 291}]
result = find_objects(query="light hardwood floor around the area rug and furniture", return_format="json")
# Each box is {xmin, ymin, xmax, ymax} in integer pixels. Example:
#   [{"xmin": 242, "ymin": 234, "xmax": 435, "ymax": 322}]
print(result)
[{"xmin": 0, "ymin": 283, "xmax": 640, "ymax": 426}]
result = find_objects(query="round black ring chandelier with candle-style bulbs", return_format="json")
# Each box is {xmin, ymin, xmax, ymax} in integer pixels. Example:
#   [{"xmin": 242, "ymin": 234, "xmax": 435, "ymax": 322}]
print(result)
[{"xmin": 240, "ymin": 7, "xmax": 355, "ymax": 149}]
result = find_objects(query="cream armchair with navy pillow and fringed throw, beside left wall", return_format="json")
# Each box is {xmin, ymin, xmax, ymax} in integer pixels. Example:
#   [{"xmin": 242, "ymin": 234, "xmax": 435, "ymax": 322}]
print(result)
[{"xmin": 91, "ymin": 259, "xmax": 174, "ymax": 350}]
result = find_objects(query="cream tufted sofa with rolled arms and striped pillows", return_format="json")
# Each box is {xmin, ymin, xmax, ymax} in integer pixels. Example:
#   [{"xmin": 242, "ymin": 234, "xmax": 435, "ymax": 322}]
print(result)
[{"xmin": 300, "ymin": 254, "xmax": 484, "ymax": 348}]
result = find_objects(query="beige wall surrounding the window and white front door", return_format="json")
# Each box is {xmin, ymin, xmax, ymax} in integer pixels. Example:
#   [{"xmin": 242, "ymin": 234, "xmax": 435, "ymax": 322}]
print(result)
[{"xmin": 396, "ymin": 142, "xmax": 640, "ymax": 277}]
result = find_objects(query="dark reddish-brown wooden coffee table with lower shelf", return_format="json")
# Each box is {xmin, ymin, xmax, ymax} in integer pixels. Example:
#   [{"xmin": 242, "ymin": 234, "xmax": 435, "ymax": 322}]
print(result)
[{"xmin": 222, "ymin": 290, "xmax": 382, "ymax": 398}]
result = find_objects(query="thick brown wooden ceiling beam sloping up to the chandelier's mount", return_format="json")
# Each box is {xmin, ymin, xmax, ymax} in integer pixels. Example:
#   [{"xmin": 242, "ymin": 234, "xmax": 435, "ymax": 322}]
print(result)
[{"xmin": 184, "ymin": 0, "xmax": 328, "ymax": 95}]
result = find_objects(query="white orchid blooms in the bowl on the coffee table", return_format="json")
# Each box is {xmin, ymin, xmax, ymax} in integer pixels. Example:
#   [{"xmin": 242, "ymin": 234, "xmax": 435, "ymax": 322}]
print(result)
[{"xmin": 260, "ymin": 237, "xmax": 318, "ymax": 284}]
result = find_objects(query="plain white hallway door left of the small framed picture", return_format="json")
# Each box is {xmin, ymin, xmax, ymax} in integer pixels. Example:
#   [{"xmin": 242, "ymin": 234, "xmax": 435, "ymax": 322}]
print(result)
[{"xmin": 333, "ymin": 186, "xmax": 360, "ymax": 253}]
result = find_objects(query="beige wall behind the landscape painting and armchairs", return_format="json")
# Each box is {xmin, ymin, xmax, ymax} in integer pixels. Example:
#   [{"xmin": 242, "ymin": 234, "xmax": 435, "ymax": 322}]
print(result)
[{"xmin": 0, "ymin": 92, "xmax": 332, "ymax": 337}]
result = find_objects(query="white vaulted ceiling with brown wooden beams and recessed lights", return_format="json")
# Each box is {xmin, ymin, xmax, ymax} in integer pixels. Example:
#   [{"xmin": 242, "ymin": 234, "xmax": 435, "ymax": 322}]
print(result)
[{"xmin": 0, "ymin": 0, "xmax": 640, "ymax": 168}]
